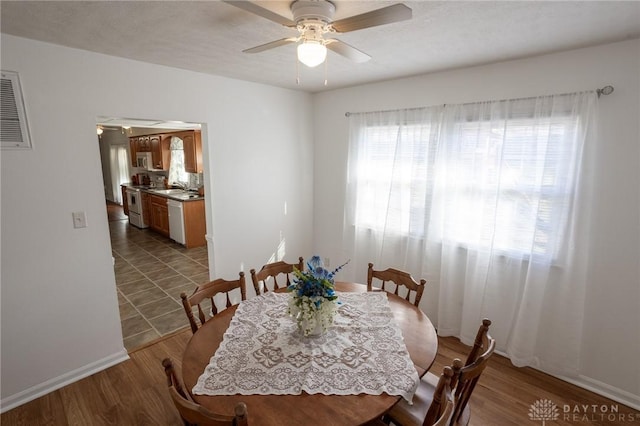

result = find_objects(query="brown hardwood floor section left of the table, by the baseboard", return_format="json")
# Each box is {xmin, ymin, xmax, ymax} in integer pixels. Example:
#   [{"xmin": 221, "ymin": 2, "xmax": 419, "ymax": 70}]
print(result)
[{"xmin": 0, "ymin": 330, "xmax": 191, "ymax": 426}]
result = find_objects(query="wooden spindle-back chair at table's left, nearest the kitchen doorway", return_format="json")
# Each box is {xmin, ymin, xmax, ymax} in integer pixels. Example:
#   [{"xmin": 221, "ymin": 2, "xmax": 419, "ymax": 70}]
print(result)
[{"xmin": 180, "ymin": 272, "xmax": 247, "ymax": 333}]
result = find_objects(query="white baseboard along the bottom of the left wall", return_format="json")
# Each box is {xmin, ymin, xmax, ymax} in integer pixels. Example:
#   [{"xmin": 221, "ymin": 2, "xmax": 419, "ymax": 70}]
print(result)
[{"xmin": 0, "ymin": 348, "xmax": 129, "ymax": 413}]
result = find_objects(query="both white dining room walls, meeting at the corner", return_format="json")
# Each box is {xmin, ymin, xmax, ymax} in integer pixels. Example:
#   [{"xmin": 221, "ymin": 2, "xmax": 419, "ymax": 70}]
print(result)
[{"xmin": 0, "ymin": 34, "xmax": 640, "ymax": 411}]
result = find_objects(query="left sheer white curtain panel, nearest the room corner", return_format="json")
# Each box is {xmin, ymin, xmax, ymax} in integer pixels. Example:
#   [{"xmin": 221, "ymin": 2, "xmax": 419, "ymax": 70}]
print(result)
[{"xmin": 344, "ymin": 107, "xmax": 442, "ymax": 272}]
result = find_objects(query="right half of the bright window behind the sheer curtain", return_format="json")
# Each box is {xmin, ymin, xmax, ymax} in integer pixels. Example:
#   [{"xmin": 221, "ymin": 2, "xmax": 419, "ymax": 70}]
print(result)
[{"xmin": 440, "ymin": 117, "xmax": 578, "ymax": 256}]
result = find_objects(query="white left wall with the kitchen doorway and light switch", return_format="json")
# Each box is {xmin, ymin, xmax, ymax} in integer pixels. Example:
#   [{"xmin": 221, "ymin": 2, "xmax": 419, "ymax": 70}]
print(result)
[{"xmin": 1, "ymin": 34, "xmax": 313, "ymax": 411}]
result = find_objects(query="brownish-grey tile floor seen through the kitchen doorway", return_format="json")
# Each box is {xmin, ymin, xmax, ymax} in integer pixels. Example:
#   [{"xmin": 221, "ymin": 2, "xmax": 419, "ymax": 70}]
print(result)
[{"xmin": 108, "ymin": 205, "xmax": 209, "ymax": 351}]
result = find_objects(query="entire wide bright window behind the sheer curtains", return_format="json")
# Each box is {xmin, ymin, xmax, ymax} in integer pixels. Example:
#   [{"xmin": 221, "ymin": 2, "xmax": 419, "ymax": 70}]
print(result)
[{"xmin": 347, "ymin": 100, "xmax": 582, "ymax": 258}]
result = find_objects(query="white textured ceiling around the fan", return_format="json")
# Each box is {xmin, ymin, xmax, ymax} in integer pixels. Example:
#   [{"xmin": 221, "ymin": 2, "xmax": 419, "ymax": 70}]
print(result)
[{"xmin": 0, "ymin": 0, "xmax": 640, "ymax": 92}]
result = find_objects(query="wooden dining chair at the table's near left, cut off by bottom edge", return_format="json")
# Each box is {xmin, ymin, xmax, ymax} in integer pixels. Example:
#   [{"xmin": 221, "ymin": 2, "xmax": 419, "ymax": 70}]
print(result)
[{"xmin": 162, "ymin": 358, "xmax": 249, "ymax": 426}]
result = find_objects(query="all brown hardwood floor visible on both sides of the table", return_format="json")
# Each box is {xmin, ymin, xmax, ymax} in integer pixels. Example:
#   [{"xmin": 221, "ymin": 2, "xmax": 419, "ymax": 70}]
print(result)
[{"xmin": 0, "ymin": 330, "xmax": 640, "ymax": 426}]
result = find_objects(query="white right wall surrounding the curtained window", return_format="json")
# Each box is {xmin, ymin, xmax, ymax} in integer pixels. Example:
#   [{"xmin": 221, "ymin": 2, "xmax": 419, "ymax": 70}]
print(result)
[{"xmin": 314, "ymin": 40, "xmax": 640, "ymax": 407}]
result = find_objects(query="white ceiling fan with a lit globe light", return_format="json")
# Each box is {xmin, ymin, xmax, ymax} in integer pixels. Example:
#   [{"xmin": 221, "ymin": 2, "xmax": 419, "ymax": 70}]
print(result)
[{"xmin": 225, "ymin": 0, "xmax": 411, "ymax": 67}]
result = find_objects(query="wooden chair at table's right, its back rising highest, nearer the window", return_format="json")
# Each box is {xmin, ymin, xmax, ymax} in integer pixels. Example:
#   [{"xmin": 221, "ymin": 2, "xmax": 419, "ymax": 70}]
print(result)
[{"xmin": 387, "ymin": 318, "xmax": 496, "ymax": 426}]
